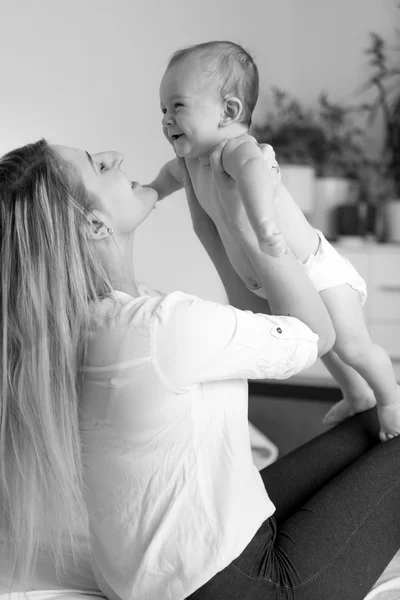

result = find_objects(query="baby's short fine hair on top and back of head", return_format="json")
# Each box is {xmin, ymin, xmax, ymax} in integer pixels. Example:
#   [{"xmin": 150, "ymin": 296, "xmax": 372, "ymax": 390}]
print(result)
[{"xmin": 167, "ymin": 41, "xmax": 259, "ymax": 127}]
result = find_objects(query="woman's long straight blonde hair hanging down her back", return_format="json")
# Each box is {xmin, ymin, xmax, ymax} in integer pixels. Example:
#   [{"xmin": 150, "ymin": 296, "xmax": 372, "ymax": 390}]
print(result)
[{"xmin": 0, "ymin": 140, "xmax": 112, "ymax": 583}]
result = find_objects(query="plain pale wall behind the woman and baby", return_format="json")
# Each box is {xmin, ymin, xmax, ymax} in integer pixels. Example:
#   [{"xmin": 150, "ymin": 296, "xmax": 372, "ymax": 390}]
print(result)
[{"xmin": 0, "ymin": 0, "xmax": 398, "ymax": 300}]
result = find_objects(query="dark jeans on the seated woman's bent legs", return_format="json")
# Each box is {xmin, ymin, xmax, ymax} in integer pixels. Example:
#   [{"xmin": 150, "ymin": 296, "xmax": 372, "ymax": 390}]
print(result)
[{"xmin": 189, "ymin": 409, "xmax": 400, "ymax": 600}]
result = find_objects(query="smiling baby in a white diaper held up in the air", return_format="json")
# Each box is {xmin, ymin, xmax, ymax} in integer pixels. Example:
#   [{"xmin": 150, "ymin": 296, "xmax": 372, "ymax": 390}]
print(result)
[{"xmin": 149, "ymin": 41, "xmax": 400, "ymax": 440}]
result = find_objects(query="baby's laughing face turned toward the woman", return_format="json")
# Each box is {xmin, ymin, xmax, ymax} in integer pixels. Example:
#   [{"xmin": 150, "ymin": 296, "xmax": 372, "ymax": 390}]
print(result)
[{"xmin": 160, "ymin": 61, "xmax": 224, "ymax": 158}]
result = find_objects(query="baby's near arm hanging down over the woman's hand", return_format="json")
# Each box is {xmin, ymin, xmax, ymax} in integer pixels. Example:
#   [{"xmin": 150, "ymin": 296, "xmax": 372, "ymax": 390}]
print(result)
[{"xmin": 222, "ymin": 135, "xmax": 282, "ymax": 255}]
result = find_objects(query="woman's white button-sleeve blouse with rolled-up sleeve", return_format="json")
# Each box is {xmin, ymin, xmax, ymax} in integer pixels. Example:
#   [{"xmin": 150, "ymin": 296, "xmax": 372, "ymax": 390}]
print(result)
[{"xmin": 81, "ymin": 288, "xmax": 318, "ymax": 600}]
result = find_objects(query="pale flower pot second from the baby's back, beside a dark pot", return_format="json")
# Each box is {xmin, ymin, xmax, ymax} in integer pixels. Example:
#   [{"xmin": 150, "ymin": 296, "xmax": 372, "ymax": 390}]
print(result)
[{"xmin": 310, "ymin": 177, "xmax": 351, "ymax": 239}]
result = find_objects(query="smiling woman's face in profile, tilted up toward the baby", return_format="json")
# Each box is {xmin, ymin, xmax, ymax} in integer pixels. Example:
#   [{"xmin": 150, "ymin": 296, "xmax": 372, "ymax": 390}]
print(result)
[{"xmin": 53, "ymin": 146, "xmax": 157, "ymax": 235}]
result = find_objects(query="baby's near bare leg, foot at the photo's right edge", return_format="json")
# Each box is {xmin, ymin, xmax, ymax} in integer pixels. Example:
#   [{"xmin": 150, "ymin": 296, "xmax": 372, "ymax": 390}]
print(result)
[{"xmin": 320, "ymin": 284, "xmax": 400, "ymax": 439}]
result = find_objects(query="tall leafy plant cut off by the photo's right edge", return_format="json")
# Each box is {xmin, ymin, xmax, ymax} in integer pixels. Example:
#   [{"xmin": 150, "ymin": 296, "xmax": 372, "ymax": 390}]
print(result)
[{"xmin": 364, "ymin": 9, "xmax": 400, "ymax": 242}]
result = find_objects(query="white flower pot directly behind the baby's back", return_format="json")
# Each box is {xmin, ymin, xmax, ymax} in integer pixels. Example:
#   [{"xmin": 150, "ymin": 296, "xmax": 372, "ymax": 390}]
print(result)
[{"xmin": 280, "ymin": 164, "xmax": 315, "ymax": 217}]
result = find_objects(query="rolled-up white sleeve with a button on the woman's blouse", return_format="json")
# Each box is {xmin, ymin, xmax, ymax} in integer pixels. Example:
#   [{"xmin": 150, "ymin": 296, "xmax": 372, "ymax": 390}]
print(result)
[{"xmin": 152, "ymin": 292, "xmax": 318, "ymax": 392}]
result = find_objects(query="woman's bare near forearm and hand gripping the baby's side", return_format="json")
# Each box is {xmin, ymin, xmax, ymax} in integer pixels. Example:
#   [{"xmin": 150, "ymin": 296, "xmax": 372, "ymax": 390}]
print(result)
[{"xmin": 210, "ymin": 145, "xmax": 335, "ymax": 356}]
